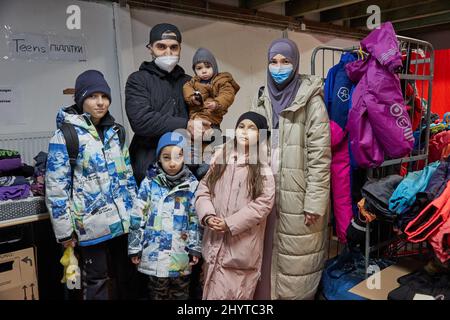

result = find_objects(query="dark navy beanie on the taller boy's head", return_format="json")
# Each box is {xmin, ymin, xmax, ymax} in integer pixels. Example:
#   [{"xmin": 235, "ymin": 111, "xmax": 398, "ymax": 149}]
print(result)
[{"xmin": 75, "ymin": 70, "xmax": 111, "ymax": 113}]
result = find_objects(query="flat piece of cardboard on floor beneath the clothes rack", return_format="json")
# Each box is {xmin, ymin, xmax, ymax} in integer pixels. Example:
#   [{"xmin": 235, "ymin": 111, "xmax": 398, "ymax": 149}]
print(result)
[{"xmin": 349, "ymin": 259, "xmax": 423, "ymax": 300}]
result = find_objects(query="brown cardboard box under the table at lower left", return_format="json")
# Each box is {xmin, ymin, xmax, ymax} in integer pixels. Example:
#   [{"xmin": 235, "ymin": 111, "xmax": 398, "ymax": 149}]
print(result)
[{"xmin": 0, "ymin": 248, "xmax": 39, "ymax": 300}]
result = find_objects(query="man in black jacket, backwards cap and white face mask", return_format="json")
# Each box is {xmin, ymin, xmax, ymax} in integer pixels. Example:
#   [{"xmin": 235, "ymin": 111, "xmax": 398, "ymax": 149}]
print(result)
[{"xmin": 125, "ymin": 23, "xmax": 210, "ymax": 184}]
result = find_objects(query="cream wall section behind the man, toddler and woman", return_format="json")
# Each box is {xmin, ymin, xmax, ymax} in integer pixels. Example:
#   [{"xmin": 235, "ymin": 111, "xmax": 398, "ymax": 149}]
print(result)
[{"xmin": 131, "ymin": 9, "xmax": 357, "ymax": 129}]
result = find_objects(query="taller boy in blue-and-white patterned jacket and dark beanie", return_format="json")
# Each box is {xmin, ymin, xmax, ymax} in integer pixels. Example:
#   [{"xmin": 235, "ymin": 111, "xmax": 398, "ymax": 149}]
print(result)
[{"xmin": 45, "ymin": 70, "xmax": 136, "ymax": 300}]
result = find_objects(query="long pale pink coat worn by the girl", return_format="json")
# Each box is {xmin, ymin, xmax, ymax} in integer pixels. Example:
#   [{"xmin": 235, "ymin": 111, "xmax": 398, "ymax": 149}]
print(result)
[{"xmin": 195, "ymin": 154, "xmax": 275, "ymax": 300}]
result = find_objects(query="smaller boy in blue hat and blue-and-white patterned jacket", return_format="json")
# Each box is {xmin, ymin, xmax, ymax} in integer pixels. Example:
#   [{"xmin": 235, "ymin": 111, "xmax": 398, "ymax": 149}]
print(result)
[{"xmin": 128, "ymin": 132, "xmax": 201, "ymax": 300}]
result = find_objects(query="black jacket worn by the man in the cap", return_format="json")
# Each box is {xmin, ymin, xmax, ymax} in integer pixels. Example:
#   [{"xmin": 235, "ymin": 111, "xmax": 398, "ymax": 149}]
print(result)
[{"xmin": 125, "ymin": 61, "xmax": 191, "ymax": 183}]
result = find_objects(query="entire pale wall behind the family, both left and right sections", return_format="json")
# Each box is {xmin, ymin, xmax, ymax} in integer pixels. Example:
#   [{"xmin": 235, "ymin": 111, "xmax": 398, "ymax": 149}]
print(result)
[{"xmin": 0, "ymin": 0, "xmax": 356, "ymax": 139}]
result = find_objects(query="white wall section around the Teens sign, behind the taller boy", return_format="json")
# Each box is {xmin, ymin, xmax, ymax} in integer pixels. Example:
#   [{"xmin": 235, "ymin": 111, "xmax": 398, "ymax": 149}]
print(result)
[{"xmin": 0, "ymin": 0, "xmax": 123, "ymax": 134}]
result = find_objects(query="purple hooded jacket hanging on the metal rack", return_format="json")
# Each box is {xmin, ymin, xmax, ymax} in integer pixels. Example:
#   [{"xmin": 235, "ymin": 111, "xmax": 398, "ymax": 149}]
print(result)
[{"xmin": 345, "ymin": 22, "xmax": 414, "ymax": 168}]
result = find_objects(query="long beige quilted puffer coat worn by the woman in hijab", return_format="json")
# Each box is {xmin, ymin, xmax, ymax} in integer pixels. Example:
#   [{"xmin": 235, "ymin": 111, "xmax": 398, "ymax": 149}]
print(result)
[{"xmin": 252, "ymin": 75, "xmax": 331, "ymax": 299}]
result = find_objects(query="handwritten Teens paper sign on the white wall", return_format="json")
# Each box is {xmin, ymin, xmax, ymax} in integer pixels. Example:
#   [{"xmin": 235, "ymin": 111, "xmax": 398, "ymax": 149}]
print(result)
[{"xmin": 8, "ymin": 33, "xmax": 86, "ymax": 61}]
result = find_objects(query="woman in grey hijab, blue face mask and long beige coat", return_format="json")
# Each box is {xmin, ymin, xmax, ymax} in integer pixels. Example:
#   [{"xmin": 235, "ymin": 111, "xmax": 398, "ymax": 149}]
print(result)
[{"xmin": 253, "ymin": 39, "xmax": 331, "ymax": 299}]
